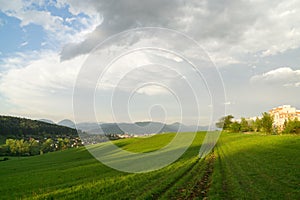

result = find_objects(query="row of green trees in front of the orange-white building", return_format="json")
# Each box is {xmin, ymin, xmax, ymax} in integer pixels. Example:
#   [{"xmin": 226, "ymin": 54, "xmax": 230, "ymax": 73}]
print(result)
[{"xmin": 216, "ymin": 112, "xmax": 300, "ymax": 134}]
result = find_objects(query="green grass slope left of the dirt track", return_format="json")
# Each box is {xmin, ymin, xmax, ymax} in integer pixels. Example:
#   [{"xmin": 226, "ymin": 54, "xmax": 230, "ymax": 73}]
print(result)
[{"xmin": 0, "ymin": 133, "xmax": 204, "ymax": 199}]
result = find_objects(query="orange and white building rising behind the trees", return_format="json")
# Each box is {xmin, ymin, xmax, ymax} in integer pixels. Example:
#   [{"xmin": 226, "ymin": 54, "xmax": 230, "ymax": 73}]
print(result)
[{"xmin": 269, "ymin": 105, "xmax": 300, "ymax": 131}]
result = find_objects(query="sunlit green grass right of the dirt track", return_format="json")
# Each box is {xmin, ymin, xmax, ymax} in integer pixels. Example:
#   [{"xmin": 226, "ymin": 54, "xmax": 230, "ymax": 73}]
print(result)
[{"xmin": 209, "ymin": 133, "xmax": 300, "ymax": 199}]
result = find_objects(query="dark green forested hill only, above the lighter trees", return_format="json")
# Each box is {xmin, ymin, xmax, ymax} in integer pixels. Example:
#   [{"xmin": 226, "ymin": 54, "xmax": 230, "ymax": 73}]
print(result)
[{"xmin": 0, "ymin": 116, "xmax": 78, "ymax": 138}]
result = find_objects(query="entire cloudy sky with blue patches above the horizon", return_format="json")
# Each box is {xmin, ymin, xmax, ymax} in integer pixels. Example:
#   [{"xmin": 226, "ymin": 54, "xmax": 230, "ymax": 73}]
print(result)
[{"xmin": 0, "ymin": 0, "xmax": 300, "ymax": 125}]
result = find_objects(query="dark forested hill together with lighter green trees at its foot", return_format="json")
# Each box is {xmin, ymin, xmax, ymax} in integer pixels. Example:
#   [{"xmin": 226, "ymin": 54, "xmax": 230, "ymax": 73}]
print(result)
[{"xmin": 0, "ymin": 116, "xmax": 82, "ymax": 156}]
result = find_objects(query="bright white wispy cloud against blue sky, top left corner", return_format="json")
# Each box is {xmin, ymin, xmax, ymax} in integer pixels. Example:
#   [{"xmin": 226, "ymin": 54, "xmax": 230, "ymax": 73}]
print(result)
[{"xmin": 0, "ymin": 0, "xmax": 101, "ymax": 43}]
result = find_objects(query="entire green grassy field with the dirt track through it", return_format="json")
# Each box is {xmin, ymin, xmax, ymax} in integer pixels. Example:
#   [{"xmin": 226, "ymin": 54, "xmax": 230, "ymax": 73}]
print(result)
[{"xmin": 0, "ymin": 133, "xmax": 300, "ymax": 199}]
